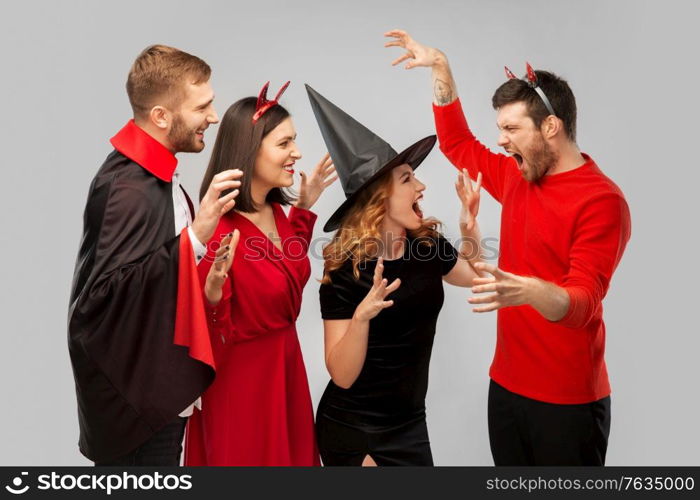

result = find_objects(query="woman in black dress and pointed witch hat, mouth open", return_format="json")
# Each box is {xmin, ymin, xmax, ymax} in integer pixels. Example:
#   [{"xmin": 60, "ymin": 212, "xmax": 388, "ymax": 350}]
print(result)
[{"xmin": 308, "ymin": 88, "xmax": 481, "ymax": 466}]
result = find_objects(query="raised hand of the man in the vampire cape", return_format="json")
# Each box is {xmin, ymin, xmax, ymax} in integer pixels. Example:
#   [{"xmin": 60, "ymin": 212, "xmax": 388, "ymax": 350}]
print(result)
[{"xmin": 192, "ymin": 169, "xmax": 243, "ymax": 245}]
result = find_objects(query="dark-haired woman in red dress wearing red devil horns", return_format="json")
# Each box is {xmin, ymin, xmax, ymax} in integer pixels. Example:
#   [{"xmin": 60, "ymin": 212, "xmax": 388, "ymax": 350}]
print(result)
[{"xmin": 185, "ymin": 82, "xmax": 336, "ymax": 466}]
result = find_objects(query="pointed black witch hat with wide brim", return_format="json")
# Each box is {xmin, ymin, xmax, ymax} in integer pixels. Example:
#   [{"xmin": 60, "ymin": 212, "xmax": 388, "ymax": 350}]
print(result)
[{"xmin": 306, "ymin": 85, "xmax": 435, "ymax": 232}]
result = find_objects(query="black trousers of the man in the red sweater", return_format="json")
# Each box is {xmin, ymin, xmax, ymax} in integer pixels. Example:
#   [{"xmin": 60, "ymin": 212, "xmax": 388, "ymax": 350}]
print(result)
[{"xmin": 488, "ymin": 380, "xmax": 610, "ymax": 465}]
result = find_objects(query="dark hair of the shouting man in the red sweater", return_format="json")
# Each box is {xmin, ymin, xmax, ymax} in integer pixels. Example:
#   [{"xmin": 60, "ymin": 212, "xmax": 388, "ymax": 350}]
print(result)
[{"xmin": 491, "ymin": 70, "xmax": 576, "ymax": 142}]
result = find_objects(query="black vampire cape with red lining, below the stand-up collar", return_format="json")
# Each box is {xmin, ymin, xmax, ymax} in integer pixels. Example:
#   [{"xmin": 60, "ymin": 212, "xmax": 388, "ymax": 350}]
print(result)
[{"xmin": 68, "ymin": 128, "xmax": 214, "ymax": 462}]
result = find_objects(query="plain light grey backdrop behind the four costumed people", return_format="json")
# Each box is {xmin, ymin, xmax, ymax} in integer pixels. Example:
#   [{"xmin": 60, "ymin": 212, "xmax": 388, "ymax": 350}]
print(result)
[{"xmin": 0, "ymin": 0, "xmax": 700, "ymax": 465}]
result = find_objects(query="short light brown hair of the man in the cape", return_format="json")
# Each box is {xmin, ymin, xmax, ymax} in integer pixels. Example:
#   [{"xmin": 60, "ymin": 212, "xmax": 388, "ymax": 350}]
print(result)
[{"xmin": 126, "ymin": 45, "xmax": 211, "ymax": 118}]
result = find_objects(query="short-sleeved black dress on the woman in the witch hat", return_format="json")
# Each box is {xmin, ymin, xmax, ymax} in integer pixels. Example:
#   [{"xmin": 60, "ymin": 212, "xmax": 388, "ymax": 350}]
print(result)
[{"xmin": 316, "ymin": 237, "xmax": 457, "ymax": 466}]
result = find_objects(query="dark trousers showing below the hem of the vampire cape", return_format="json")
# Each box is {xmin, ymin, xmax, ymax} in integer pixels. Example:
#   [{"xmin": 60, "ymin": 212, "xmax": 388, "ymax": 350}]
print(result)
[{"xmin": 95, "ymin": 417, "xmax": 187, "ymax": 467}]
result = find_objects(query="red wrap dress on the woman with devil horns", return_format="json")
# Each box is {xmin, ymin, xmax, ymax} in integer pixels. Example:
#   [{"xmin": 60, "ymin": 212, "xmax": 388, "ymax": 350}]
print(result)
[{"xmin": 185, "ymin": 203, "xmax": 320, "ymax": 466}]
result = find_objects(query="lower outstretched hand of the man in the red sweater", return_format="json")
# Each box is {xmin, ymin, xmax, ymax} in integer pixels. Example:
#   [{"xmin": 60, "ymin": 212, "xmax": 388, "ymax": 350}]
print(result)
[{"xmin": 467, "ymin": 262, "xmax": 533, "ymax": 312}]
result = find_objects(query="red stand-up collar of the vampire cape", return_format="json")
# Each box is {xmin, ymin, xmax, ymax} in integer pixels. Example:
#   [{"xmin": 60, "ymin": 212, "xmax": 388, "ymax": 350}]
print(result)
[{"xmin": 109, "ymin": 120, "xmax": 177, "ymax": 182}]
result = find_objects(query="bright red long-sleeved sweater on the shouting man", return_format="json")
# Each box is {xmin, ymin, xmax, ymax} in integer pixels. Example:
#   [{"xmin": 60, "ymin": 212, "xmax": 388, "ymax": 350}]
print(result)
[{"xmin": 433, "ymin": 100, "xmax": 630, "ymax": 404}]
